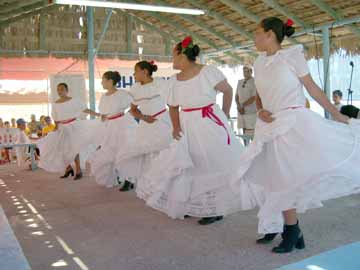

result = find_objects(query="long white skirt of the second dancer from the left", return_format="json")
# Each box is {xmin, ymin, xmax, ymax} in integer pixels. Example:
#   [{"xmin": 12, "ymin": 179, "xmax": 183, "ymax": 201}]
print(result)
[{"xmin": 87, "ymin": 114, "xmax": 141, "ymax": 187}]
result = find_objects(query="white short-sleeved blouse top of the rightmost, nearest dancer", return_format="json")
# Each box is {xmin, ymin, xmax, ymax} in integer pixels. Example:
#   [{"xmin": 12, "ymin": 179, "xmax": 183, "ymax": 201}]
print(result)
[{"xmin": 254, "ymin": 45, "xmax": 309, "ymax": 113}]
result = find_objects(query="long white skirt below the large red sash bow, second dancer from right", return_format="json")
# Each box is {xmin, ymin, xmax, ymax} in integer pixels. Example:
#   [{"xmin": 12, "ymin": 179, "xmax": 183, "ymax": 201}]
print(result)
[{"xmin": 141, "ymin": 105, "xmax": 243, "ymax": 219}]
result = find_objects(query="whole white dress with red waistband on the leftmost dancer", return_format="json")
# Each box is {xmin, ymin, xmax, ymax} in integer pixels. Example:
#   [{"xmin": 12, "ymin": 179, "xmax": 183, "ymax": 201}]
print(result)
[{"xmin": 36, "ymin": 99, "xmax": 98, "ymax": 172}]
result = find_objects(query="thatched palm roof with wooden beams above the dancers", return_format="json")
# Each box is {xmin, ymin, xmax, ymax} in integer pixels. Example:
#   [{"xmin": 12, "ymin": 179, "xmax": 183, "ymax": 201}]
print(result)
[{"xmin": 0, "ymin": 0, "xmax": 360, "ymax": 63}]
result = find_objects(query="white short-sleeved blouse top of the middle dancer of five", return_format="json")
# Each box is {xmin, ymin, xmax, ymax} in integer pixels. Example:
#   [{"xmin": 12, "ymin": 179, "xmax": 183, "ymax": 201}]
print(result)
[{"xmin": 130, "ymin": 78, "xmax": 167, "ymax": 115}]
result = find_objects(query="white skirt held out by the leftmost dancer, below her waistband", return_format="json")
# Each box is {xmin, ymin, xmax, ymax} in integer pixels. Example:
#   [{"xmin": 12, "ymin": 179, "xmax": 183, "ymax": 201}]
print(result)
[{"xmin": 36, "ymin": 120, "xmax": 99, "ymax": 173}]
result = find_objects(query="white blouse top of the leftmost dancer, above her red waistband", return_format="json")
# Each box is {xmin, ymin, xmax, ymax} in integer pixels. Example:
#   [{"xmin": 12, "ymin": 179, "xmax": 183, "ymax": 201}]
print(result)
[{"xmin": 51, "ymin": 98, "xmax": 86, "ymax": 121}]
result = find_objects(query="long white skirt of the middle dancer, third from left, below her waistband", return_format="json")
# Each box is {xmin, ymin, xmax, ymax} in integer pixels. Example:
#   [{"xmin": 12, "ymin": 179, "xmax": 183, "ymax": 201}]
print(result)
[{"xmin": 115, "ymin": 112, "xmax": 172, "ymax": 184}]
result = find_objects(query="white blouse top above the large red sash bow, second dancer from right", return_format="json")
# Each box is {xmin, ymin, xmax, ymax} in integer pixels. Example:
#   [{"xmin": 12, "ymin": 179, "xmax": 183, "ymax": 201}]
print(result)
[{"xmin": 167, "ymin": 66, "xmax": 226, "ymax": 109}]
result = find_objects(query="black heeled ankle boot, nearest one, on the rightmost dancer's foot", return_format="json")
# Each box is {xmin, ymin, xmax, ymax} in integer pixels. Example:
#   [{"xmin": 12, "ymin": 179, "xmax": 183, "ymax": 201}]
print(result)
[{"xmin": 272, "ymin": 222, "xmax": 305, "ymax": 253}]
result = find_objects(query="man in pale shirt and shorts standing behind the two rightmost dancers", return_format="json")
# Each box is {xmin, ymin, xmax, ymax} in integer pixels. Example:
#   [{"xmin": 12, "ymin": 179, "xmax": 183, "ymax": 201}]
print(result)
[{"xmin": 235, "ymin": 66, "xmax": 257, "ymax": 135}]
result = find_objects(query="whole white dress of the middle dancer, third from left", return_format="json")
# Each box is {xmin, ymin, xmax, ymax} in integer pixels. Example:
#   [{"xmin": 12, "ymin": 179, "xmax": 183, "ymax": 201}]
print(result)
[{"xmin": 116, "ymin": 79, "xmax": 172, "ymax": 187}]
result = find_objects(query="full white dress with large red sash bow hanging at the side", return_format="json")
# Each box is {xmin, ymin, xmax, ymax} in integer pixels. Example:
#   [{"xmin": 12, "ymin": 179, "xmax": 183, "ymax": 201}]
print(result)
[{"xmin": 138, "ymin": 66, "xmax": 242, "ymax": 219}]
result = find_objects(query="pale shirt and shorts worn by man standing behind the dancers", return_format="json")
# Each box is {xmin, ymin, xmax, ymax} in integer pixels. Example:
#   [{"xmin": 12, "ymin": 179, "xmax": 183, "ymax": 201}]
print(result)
[{"xmin": 236, "ymin": 78, "xmax": 257, "ymax": 129}]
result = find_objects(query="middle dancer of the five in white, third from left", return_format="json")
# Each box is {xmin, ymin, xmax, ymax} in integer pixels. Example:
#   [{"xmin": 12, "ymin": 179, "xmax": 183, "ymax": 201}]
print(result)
[{"xmin": 117, "ymin": 61, "xmax": 171, "ymax": 192}]
